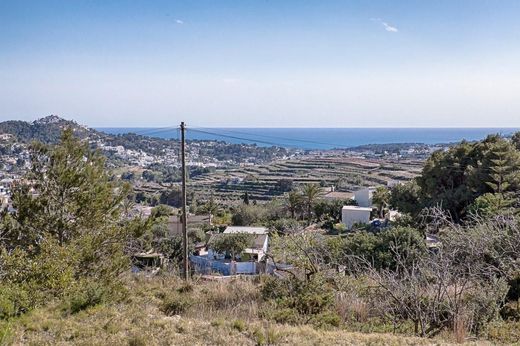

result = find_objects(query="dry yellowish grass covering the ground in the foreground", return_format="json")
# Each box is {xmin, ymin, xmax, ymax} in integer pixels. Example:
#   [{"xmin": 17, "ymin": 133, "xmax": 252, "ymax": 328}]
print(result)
[{"xmin": 0, "ymin": 277, "xmax": 502, "ymax": 346}]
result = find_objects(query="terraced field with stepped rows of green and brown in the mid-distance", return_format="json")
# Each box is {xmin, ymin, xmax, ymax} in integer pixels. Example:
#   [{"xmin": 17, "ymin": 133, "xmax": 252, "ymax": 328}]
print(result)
[{"xmin": 189, "ymin": 156, "xmax": 423, "ymax": 200}]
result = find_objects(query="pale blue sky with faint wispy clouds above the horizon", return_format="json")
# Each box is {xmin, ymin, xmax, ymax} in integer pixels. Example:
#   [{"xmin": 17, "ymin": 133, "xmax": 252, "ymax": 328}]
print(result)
[{"xmin": 0, "ymin": 0, "xmax": 520, "ymax": 127}]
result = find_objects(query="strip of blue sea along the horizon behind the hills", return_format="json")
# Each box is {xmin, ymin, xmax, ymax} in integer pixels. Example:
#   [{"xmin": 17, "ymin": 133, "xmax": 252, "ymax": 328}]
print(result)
[{"xmin": 97, "ymin": 126, "xmax": 520, "ymax": 149}]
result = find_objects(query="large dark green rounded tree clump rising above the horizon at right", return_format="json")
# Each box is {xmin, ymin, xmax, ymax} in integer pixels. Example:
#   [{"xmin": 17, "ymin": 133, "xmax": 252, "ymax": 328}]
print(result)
[{"xmin": 417, "ymin": 135, "xmax": 520, "ymax": 222}]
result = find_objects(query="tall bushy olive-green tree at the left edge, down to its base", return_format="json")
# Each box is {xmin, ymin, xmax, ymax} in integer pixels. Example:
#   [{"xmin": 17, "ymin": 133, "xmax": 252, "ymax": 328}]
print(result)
[{"xmin": 0, "ymin": 130, "xmax": 134, "ymax": 315}]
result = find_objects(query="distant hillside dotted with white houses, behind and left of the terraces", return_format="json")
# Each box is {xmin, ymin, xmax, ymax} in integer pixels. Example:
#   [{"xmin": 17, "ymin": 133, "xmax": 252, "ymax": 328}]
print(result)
[{"xmin": 0, "ymin": 115, "xmax": 298, "ymax": 171}]
